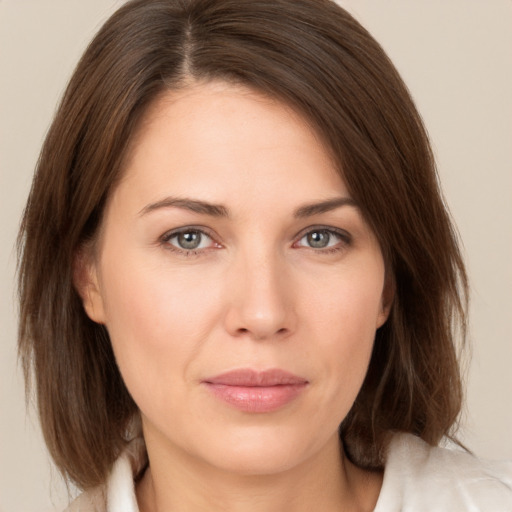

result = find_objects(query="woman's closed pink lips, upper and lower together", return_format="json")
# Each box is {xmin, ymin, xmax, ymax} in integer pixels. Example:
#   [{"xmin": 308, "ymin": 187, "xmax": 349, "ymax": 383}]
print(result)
[{"xmin": 202, "ymin": 369, "xmax": 308, "ymax": 413}]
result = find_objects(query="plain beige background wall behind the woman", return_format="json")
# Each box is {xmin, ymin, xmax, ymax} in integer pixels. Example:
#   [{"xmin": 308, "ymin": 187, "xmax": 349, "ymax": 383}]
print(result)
[{"xmin": 0, "ymin": 0, "xmax": 512, "ymax": 512}]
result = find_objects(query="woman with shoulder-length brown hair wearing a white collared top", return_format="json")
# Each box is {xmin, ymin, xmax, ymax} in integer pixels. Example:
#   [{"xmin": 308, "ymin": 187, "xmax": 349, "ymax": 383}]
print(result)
[{"xmin": 20, "ymin": 0, "xmax": 512, "ymax": 512}]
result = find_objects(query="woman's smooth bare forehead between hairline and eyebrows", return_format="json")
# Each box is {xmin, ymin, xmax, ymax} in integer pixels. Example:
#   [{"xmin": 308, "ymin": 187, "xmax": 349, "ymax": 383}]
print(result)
[{"xmin": 115, "ymin": 82, "xmax": 347, "ymax": 214}]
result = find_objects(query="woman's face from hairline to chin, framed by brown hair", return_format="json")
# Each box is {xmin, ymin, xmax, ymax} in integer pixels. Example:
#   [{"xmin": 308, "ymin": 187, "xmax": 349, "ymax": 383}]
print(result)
[{"xmin": 81, "ymin": 83, "xmax": 389, "ymax": 474}]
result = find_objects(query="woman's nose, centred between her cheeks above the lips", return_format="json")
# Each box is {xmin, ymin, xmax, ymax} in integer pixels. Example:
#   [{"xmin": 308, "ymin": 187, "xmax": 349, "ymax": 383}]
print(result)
[{"xmin": 225, "ymin": 248, "xmax": 296, "ymax": 340}]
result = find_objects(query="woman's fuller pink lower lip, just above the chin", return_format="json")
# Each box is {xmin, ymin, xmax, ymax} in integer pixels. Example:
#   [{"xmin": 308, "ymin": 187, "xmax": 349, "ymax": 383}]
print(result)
[{"xmin": 205, "ymin": 382, "xmax": 306, "ymax": 413}]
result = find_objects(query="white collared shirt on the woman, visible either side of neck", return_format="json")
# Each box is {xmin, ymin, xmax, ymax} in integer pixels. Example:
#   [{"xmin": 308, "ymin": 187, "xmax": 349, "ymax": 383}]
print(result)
[{"xmin": 65, "ymin": 434, "xmax": 512, "ymax": 512}]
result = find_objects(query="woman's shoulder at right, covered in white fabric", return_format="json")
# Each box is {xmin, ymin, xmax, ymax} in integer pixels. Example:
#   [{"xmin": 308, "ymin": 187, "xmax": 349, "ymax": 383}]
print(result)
[{"xmin": 375, "ymin": 434, "xmax": 512, "ymax": 512}]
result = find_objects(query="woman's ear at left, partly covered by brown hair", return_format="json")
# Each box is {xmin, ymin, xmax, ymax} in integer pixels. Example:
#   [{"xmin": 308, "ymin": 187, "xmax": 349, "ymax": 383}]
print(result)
[{"xmin": 73, "ymin": 246, "xmax": 105, "ymax": 324}]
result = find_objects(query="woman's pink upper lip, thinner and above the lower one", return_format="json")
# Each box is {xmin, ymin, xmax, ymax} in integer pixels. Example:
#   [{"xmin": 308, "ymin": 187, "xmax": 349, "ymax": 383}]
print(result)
[{"xmin": 203, "ymin": 368, "xmax": 308, "ymax": 387}]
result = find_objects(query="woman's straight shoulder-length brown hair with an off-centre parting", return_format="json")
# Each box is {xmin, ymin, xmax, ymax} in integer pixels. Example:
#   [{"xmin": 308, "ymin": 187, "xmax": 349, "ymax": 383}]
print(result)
[{"xmin": 19, "ymin": 0, "xmax": 467, "ymax": 488}]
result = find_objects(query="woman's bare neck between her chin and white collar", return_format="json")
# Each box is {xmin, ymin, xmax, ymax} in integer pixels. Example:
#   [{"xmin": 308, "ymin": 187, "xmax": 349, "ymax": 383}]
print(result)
[{"xmin": 137, "ymin": 436, "xmax": 382, "ymax": 512}]
